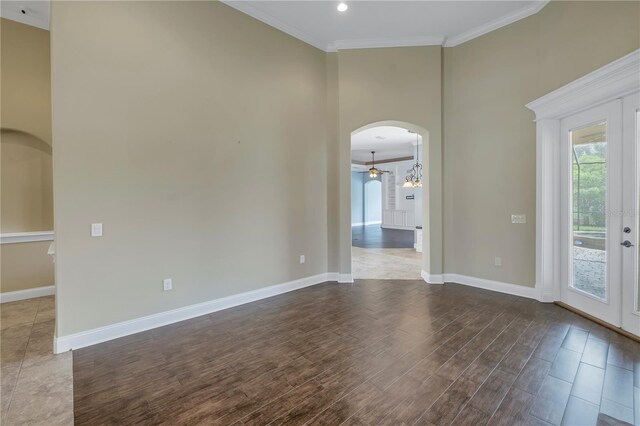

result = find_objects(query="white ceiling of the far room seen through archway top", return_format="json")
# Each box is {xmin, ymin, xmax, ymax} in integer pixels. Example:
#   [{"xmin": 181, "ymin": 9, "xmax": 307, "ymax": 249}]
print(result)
[{"xmin": 351, "ymin": 126, "xmax": 422, "ymax": 162}]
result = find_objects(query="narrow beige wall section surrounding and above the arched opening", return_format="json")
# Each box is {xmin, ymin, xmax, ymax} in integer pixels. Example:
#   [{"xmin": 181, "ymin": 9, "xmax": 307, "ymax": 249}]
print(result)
[{"xmin": 329, "ymin": 46, "xmax": 442, "ymax": 273}]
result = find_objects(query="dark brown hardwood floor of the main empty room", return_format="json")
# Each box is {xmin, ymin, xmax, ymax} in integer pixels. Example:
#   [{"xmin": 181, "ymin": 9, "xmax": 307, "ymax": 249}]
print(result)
[{"xmin": 73, "ymin": 280, "xmax": 640, "ymax": 425}]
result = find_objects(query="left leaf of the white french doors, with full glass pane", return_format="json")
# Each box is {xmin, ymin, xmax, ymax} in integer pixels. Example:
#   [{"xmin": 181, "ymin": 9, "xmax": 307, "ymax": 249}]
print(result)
[{"xmin": 560, "ymin": 100, "xmax": 622, "ymax": 327}]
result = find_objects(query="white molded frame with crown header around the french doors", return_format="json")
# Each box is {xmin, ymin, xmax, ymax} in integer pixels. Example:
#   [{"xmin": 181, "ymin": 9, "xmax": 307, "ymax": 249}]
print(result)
[{"xmin": 526, "ymin": 49, "xmax": 640, "ymax": 302}]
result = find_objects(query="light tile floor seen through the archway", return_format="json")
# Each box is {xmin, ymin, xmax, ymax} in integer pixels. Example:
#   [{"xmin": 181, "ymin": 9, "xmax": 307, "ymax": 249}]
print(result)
[{"xmin": 351, "ymin": 247, "xmax": 422, "ymax": 280}]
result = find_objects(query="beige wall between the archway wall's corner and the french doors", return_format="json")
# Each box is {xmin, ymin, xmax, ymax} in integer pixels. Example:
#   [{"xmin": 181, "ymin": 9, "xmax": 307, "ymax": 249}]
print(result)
[{"xmin": 443, "ymin": 1, "xmax": 640, "ymax": 286}]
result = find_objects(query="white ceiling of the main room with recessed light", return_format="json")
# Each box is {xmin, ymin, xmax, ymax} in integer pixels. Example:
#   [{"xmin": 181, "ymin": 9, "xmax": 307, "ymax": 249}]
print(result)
[{"xmin": 222, "ymin": 0, "xmax": 548, "ymax": 52}]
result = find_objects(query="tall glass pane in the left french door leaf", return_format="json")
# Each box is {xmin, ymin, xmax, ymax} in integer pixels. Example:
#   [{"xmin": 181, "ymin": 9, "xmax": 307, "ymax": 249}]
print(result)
[{"xmin": 570, "ymin": 122, "xmax": 607, "ymax": 299}]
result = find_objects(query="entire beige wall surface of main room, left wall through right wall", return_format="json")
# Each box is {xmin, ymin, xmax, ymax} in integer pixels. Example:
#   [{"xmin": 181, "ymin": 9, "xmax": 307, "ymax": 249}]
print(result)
[{"xmin": 52, "ymin": 2, "xmax": 639, "ymax": 336}]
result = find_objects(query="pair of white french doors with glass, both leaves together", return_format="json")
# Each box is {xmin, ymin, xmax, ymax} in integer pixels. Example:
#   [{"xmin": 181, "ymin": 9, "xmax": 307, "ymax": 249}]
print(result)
[{"xmin": 560, "ymin": 94, "xmax": 640, "ymax": 335}]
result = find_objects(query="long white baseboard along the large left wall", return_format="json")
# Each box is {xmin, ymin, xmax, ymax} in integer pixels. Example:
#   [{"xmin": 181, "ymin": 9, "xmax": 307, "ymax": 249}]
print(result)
[{"xmin": 53, "ymin": 273, "xmax": 338, "ymax": 354}]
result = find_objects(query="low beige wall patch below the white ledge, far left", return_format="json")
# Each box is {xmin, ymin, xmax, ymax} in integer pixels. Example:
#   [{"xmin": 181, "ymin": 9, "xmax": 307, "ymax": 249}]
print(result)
[{"xmin": 0, "ymin": 241, "xmax": 53, "ymax": 293}]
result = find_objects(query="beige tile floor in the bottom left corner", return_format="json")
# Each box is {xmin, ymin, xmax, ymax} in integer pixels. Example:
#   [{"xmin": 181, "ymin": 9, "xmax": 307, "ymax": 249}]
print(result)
[{"xmin": 0, "ymin": 296, "xmax": 73, "ymax": 426}]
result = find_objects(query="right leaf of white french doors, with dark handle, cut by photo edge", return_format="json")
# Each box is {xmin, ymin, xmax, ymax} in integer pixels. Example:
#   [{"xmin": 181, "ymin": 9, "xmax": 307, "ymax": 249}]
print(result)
[{"xmin": 621, "ymin": 93, "xmax": 640, "ymax": 336}]
